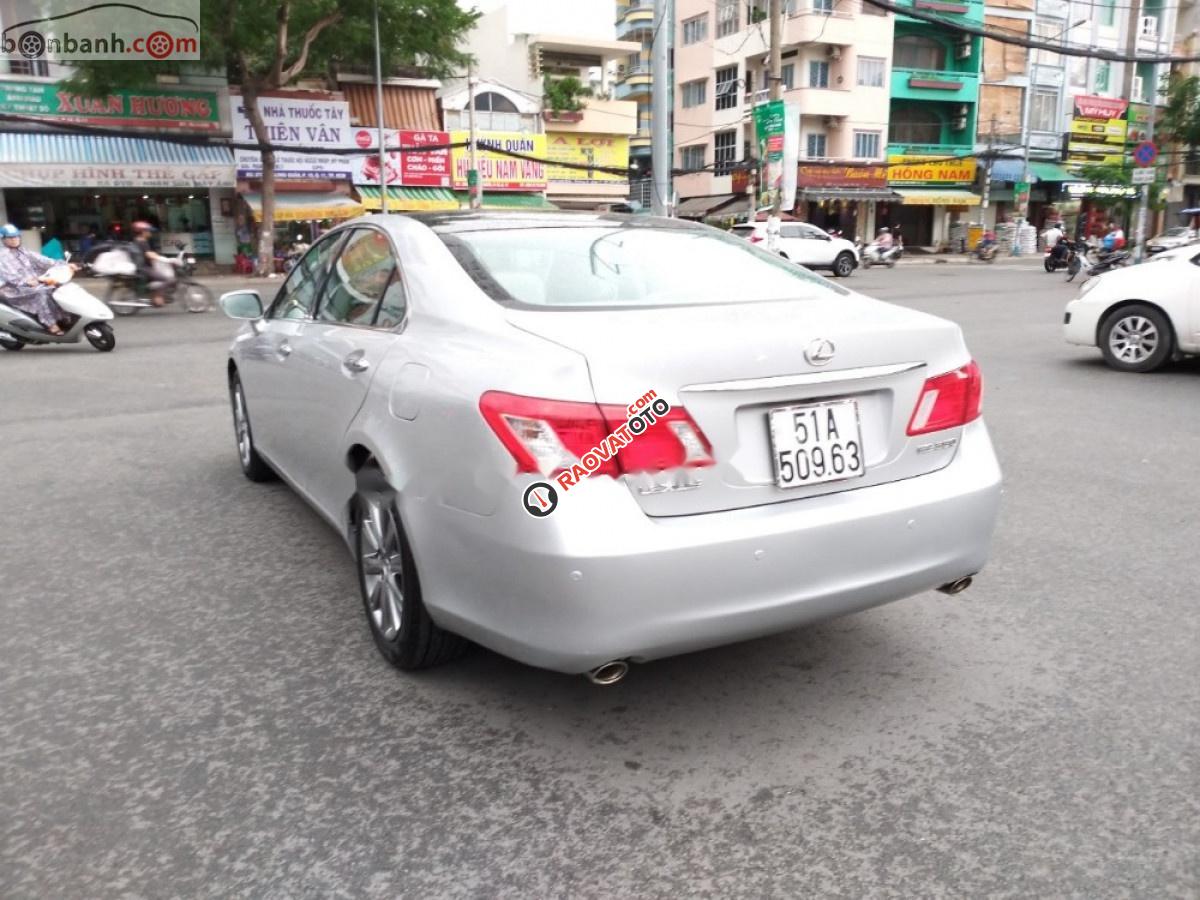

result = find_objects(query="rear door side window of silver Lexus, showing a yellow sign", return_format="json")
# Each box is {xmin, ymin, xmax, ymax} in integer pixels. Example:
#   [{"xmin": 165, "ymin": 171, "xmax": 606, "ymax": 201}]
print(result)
[{"xmin": 317, "ymin": 228, "xmax": 403, "ymax": 325}]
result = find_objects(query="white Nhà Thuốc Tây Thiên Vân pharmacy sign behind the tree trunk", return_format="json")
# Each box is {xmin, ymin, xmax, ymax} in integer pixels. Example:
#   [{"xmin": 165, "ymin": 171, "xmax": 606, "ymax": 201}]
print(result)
[{"xmin": 229, "ymin": 94, "xmax": 359, "ymax": 180}]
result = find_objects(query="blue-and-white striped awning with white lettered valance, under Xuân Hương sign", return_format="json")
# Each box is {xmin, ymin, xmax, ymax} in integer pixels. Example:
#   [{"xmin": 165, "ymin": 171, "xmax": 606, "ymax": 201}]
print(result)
[{"xmin": 0, "ymin": 132, "xmax": 235, "ymax": 188}]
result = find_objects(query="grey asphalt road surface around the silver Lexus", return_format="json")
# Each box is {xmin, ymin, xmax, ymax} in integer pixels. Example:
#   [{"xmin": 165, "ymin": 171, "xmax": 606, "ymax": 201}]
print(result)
[{"xmin": 0, "ymin": 264, "xmax": 1200, "ymax": 900}]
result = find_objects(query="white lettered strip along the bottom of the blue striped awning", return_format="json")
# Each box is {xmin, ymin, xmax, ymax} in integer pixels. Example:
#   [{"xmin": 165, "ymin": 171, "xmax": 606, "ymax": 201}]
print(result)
[{"xmin": 0, "ymin": 162, "xmax": 234, "ymax": 188}]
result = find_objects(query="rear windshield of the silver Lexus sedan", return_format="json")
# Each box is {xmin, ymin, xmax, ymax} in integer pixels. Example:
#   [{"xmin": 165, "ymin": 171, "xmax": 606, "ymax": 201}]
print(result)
[{"xmin": 439, "ymin": 224, "xmax": 850, "ymax": 308}]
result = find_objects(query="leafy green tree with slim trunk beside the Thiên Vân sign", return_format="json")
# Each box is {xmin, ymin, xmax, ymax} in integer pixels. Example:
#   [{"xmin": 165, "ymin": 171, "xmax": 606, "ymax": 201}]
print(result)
[{"xmin": 71, "ymin": 0, "xmax": 479, "ymax": 275}]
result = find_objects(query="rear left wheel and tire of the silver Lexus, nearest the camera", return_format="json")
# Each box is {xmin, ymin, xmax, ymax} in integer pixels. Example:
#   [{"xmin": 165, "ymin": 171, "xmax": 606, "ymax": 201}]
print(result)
[{"xmin": 353, "ymin": 472, "xmax": 470, "ymax": 671}]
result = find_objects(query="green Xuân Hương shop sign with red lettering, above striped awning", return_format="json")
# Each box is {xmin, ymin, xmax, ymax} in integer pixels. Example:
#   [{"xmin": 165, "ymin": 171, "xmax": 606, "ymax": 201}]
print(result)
[{"xmin": 0, "ymin": 82, "xmax": 221, "ymax": 131}]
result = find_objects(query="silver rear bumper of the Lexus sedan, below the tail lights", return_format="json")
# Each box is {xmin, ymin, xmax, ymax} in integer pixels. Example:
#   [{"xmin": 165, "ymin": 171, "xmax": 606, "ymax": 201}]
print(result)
[{"xmin": 406, "ymin": 420, "xmax": 1001, "ymax": 673}]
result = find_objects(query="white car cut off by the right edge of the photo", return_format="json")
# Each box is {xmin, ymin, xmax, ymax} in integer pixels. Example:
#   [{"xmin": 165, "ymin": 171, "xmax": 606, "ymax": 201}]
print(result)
[{"xmin": 1063, "ymin": 247, "xmax": 1200, "ymax": 372}]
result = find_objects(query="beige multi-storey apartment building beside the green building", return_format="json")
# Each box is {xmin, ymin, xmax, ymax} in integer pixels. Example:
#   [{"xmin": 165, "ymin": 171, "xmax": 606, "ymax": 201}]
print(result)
[{"xmin": 673, "ymin": 0, "xmax": 893, "ymax": 234}]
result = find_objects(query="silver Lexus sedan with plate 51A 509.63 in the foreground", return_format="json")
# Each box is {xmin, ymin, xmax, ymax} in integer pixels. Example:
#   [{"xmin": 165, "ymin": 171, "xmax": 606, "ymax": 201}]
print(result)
[{"xmin": 222, "ymin": 212, "xmax": 1000, "ymax": 683}]
